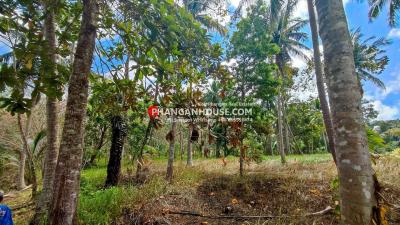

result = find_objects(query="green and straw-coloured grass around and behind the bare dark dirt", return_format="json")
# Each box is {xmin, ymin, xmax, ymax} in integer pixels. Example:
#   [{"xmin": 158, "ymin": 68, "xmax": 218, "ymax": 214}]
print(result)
[{"xmin": 6, "ymin": 153, "xmax": 400, "ymax": 225}]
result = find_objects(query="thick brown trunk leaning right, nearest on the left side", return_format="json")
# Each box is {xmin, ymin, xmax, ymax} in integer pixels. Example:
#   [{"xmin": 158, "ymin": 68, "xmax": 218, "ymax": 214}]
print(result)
[{"xmin": 49, "ymin": 0, "xmax": 98, "ymax": 225}]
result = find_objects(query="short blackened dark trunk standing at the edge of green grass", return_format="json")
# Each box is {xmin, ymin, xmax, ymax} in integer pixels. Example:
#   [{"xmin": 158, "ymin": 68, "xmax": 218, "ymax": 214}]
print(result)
[{"xmin": 105, "ymin": 115, "xmax": 126, "ymax": 187}]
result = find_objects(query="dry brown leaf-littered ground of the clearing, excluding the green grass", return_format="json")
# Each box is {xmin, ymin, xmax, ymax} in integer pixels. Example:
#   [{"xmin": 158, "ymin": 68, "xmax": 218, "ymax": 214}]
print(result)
[{"xmin": 6, "ymin": 158, "xmax": 400, "ymax": 225}]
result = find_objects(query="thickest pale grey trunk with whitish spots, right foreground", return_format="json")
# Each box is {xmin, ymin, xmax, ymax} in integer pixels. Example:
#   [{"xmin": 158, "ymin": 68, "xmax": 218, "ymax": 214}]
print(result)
[{"xmin": 316, "ymin": 0, "xmax": 377, "ymax": 225}]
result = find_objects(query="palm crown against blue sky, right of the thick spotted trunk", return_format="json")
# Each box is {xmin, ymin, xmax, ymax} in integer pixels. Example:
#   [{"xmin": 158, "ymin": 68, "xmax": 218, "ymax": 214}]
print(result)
[{"xmin": 350, "ymin": 28, "xmax": 391, "ymax": 93}]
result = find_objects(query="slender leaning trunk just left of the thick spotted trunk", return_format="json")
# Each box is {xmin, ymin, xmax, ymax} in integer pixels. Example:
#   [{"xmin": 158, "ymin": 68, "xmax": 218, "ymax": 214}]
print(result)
[{"xmin": 307, "ymin": 0, "xmax": 336, "ymax": 163}]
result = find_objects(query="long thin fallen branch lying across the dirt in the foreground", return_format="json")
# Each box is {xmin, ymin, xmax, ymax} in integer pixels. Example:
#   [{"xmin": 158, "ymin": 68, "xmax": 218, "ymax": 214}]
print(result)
[{"xmin": 168, "ymin": 206, "xmax": 333, "ymax": 220}]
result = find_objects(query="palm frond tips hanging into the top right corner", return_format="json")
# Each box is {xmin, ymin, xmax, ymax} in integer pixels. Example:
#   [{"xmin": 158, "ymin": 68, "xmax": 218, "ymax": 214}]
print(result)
[{"xmin": 368, "ymin": 0, "xmax": 400, "ymax": 27}]
